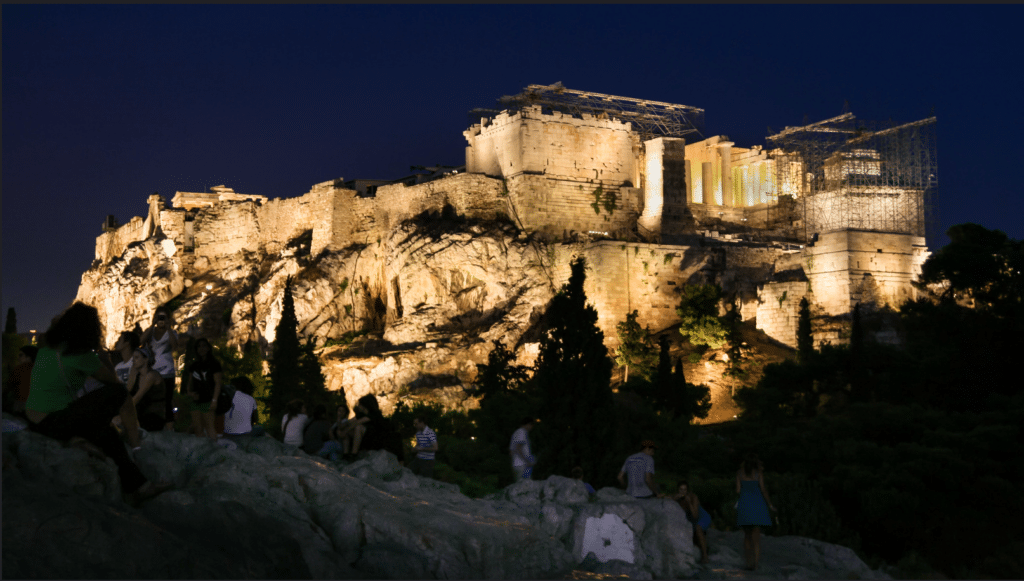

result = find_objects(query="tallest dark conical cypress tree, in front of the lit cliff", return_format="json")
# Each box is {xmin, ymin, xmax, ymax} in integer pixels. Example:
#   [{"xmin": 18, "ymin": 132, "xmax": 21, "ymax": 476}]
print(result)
[{"xmin": 534, "ymin": 257, "xmax": 618, "ymax": 478}]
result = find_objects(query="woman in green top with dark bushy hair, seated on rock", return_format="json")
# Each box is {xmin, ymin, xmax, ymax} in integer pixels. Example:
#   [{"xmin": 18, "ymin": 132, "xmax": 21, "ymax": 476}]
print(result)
[{"xmin": 26, "ymin": 302, "xmax": 168, "ymax": 501}]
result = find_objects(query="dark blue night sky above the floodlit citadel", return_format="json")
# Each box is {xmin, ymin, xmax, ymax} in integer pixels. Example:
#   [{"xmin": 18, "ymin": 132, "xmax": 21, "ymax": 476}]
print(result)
[{"xmin": 2, "ymin": 5, "xmax": 1024, "ymax": 332}]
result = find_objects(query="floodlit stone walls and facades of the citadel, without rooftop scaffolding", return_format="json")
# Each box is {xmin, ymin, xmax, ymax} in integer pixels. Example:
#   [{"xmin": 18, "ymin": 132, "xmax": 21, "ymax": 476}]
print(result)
[{"xmin": 95, "ymin": 93, "xmax": 928, "ymax": 346}]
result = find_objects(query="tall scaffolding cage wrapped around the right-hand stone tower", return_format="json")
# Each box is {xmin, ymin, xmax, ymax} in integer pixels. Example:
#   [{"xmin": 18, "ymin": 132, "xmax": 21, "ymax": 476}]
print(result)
[{"xmin": 767, "ymin": 113, "xmax": 938, "ymax": 241}]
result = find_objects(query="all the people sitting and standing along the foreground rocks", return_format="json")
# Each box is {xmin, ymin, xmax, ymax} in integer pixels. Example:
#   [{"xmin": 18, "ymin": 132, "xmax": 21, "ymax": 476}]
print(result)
[{"xmin": 5, "ymin": 302, "xmax": 775, "ymax": 570}]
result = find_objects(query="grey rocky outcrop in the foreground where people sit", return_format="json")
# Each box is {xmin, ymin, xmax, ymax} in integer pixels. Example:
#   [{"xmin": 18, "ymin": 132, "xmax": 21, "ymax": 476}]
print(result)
[{"xmin": 3, "ymin": 422, "xmax": 886, "ymax": 579}]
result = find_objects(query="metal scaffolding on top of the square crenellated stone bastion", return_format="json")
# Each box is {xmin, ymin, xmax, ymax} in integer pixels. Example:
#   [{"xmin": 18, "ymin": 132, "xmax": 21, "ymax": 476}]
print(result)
[{"xmin": 470, "ymin": 83, "xmax": 703, "ymax": 141}]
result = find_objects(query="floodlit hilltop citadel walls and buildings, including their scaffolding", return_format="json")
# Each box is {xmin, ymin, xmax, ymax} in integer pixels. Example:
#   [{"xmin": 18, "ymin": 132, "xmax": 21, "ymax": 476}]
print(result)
[{"xmin": 86, "ymin": 84, "xmax": 937, "ymax": 352}]
